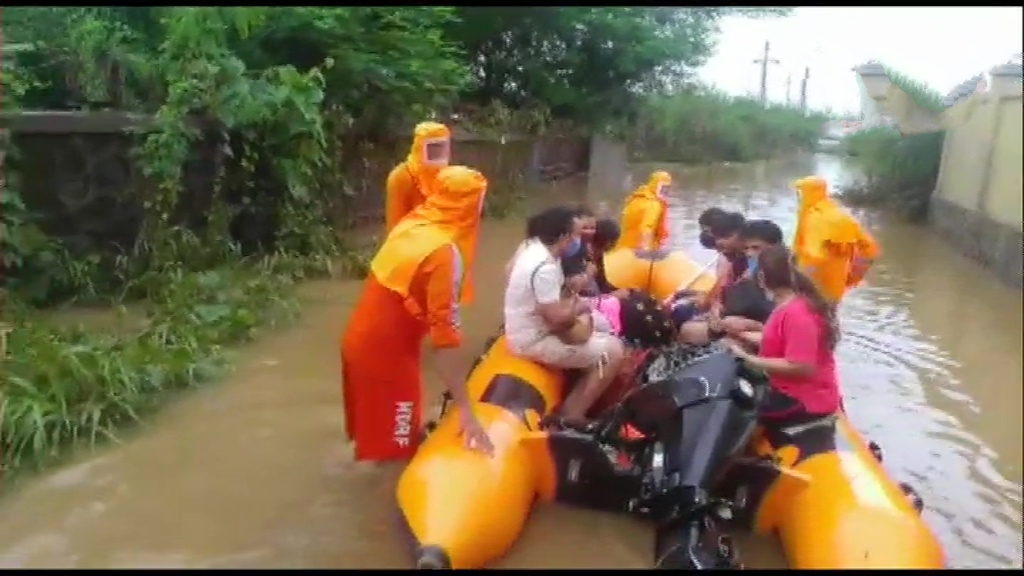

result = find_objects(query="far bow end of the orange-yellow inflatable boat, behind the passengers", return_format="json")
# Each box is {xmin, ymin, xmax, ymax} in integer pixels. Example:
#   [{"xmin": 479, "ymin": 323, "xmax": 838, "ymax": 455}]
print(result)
[{"xmin": 604, "ymin": 248, "xmax": 715, "ymax": 300}]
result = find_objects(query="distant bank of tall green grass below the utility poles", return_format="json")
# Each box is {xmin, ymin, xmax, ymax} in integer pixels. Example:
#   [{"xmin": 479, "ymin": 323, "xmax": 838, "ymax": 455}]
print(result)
[{"xmin": 631, "ymin": 90, "xmax": 828, "ymax": 163}]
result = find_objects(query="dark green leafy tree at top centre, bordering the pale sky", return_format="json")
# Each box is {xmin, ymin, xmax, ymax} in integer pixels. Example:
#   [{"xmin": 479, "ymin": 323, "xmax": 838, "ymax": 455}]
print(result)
[{"xmin": 447, "ymin": 7, "xmax": 785, "ymax": 122}]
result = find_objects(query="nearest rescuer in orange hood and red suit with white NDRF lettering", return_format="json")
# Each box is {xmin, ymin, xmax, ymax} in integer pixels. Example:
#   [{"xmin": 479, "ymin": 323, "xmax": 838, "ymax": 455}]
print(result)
[{"xmin": 341, "ymin": 166, "xmax": 493, "ymax": 460}]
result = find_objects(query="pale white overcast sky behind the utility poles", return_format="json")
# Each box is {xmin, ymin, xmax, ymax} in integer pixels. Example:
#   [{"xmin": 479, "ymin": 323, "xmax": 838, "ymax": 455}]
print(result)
[{"xmin": 700, "ymin": 7, "xmax": 1024, "ymax": 112}]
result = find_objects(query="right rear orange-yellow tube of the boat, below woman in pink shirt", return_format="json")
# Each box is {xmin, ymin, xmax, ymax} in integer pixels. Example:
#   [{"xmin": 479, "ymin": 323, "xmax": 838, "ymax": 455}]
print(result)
[{"xmin": 739, "ymin": 414, "xmax": 945, "ymax": 570}]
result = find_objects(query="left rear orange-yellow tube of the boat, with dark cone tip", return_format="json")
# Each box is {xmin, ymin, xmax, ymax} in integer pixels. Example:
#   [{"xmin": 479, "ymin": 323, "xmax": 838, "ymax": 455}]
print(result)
[{"xmin": 397, "ymin": 336, "xmax": 563, "ymax": 569}]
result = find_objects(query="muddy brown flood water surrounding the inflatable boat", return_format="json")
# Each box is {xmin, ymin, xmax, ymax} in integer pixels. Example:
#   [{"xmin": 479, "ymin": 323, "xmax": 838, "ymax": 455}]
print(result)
[{"xmin": 0, "ymin": 156, "xmax": 1024, "ymax": 568}]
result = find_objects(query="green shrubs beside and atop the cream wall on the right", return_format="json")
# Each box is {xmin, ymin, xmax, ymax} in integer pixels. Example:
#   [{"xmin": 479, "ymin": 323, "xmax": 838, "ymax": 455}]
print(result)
[{"xmin": 843, "ymin": 69, "xmax": 945, "ymax": 221}]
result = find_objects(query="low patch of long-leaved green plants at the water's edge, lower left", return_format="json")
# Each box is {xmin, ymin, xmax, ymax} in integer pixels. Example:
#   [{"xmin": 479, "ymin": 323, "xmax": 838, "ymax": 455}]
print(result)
[{"xmin": 0, "ymin": 261, "xmax": 301, "ymax": 471}]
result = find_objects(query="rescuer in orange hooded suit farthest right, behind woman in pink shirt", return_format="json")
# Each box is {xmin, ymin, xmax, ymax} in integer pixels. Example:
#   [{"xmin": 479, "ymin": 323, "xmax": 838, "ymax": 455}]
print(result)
[{"xmin": 793, "ymin": 176, "xmax": 882, "ymax": 304}]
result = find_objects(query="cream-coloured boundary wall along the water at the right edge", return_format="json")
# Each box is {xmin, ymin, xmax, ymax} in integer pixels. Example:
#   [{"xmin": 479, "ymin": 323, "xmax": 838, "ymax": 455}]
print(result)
[{"xmin": 930, "ymin": 76, "xmax": 1024, "ymax": 288}]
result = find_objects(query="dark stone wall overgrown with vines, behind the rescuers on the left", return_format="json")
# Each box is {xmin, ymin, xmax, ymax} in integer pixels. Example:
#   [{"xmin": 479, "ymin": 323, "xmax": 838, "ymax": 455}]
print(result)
[{"xmin": 0, "ymin": 111, "xmax": 591, "ymax": 252}]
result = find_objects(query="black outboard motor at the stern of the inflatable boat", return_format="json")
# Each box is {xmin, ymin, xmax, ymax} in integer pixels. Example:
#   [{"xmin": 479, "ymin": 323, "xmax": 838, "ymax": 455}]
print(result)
[{"xmin": 549, "ymin": 346, "xmax": 763, "ymax": 570}]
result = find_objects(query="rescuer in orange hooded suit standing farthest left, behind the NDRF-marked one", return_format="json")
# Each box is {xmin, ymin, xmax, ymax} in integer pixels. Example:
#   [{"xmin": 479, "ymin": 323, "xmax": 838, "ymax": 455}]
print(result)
[{"xmin": 384, "ymin": 122, "xmax": 452, "ymax": 232}]
